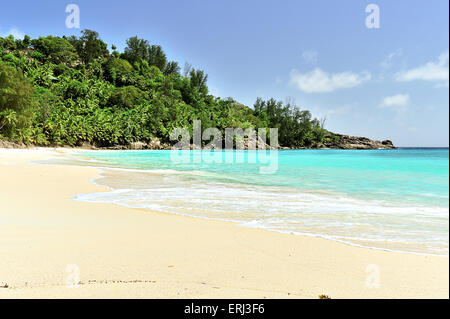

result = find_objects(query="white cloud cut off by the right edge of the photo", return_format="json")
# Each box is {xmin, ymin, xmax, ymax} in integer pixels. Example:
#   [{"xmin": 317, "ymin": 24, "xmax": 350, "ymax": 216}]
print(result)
[{"xmin": 395, "ymin": 51, "xmax": 449, "ymax": 87}]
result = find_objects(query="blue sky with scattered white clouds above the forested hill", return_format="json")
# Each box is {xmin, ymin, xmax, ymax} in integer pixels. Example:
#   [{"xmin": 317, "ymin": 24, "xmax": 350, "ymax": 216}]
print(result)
[{"xmin": 0, "ymin": 0, "xmax": 449, "ymax": 146}]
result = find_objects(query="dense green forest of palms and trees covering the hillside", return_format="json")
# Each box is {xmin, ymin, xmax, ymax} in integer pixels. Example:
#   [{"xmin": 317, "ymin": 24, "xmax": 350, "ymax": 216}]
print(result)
[{"xmin": 0, "ymin": 30, "xmax": 328, "ymax": 147}]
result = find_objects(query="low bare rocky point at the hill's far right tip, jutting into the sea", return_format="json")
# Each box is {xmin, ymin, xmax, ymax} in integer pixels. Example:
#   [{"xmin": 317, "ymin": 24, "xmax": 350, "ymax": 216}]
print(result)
[{"xmin": 323, "ymin": 134, "xmax": 395, "ymax": 150}]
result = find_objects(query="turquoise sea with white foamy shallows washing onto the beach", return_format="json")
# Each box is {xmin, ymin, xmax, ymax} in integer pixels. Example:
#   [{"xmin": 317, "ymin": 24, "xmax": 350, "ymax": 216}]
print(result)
[{"xmin": 69, "ymin": 149, "xmax": 449, "ymax": 255}]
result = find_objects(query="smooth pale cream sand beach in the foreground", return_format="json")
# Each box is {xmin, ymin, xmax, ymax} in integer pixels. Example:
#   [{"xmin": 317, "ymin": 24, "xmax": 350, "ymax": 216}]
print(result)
[{"xmin": 0, "ymin": 149, "xmax": 449, "ymax": 299}]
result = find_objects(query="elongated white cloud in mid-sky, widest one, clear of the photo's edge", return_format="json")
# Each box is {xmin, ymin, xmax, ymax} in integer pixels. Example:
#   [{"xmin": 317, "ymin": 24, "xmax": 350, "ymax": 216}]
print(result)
[{"xmin": 290, "ymin": 68, "xmax": 371, "ymax": 93}]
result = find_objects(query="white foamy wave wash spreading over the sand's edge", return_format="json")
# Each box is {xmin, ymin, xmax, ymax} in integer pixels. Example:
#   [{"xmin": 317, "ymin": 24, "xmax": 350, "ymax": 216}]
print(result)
[{"xmin": 74, "ymin": 169, "xmax": 449, "ymax": 255}]
